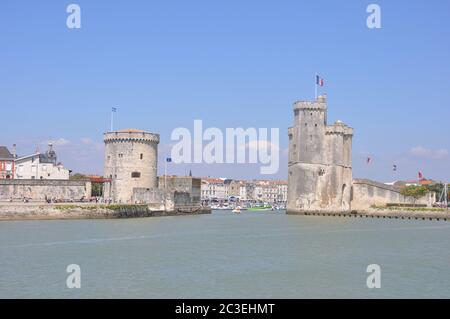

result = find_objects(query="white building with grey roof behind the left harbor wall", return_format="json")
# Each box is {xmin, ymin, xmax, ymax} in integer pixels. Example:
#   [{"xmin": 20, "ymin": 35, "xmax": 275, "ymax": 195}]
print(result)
[{"xmin": 14, "ymin": 144, "xmax": 70, "ymax": 180}]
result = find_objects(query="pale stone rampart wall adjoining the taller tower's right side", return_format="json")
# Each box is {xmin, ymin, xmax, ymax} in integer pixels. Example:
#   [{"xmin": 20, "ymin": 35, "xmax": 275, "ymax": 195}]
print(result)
[{"xmin": 351, "ymin": 179, "xmax": 435, "ymax": 210}]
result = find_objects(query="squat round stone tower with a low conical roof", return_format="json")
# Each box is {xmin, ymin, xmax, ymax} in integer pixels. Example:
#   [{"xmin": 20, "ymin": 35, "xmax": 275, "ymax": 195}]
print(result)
[{"xmin": 103, "ymin": 129, "xmax": 159, "ymax": 203}]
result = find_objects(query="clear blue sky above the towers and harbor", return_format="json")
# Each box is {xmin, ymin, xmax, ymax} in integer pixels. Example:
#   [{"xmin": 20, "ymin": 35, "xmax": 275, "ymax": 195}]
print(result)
[{"xmin": 0, "ymin": 0, "xmax": 450, "ymax": 181}]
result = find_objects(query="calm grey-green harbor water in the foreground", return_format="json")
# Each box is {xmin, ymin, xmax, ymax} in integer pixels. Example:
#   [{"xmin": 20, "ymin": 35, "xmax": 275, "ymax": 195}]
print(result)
[{"xmin": 0, "ymin": 211, "xmax": 450, "ymax": 298}]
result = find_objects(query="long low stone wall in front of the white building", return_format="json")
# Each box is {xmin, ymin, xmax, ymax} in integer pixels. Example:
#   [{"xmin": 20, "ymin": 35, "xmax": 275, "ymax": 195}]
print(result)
[{"xmin": 0, "ymin": 179, "xmax": 92, "ymax": 202}]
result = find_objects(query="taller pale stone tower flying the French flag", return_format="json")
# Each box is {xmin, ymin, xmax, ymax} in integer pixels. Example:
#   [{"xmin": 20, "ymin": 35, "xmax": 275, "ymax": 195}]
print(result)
[{"xmin": 287, "ymin": 95, "xmax": 353, "ymax": 214}]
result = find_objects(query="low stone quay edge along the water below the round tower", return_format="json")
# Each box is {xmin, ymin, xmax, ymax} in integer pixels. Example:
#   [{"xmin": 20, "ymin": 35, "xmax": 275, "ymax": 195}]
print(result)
[{"xmin": 0, "ymin": 203, "xmax": 211, "ymax": 222}]
